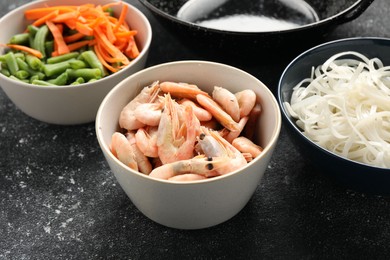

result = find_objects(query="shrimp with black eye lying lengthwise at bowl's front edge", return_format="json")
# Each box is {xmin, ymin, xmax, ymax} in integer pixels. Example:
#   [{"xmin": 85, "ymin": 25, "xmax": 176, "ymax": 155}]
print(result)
[{"xmin": 149, "ymin": 156, "xmax": 230, "ymax": 180}]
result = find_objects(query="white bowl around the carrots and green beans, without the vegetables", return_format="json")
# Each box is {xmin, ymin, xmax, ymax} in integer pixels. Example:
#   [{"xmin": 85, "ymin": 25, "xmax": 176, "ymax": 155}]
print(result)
[{"xmin": 0, "ymin": 0, "xmax": 152, "ymax": 125}]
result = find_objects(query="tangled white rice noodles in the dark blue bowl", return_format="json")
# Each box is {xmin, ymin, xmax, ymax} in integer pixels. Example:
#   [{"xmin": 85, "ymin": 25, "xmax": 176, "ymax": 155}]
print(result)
[{"xmin": 284, "ymin": 51, "xmax": 390, "ymax": 168}]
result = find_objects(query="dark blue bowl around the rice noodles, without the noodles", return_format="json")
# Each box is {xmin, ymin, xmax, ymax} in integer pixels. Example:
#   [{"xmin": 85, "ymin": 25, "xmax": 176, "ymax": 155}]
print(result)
[{"xmin": 277, "ymin": 37, "xmax": 390, "ymax": 195}]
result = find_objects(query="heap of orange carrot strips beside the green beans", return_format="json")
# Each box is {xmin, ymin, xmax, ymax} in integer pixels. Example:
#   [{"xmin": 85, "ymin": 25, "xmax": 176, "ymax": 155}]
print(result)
[{"xmin": 21, "ymin": 1, "xmax": 140, "ymax": 72}]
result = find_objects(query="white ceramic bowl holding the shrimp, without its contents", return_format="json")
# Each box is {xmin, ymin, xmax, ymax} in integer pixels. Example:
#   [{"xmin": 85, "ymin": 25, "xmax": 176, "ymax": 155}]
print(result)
[{"xmin": 96, "ymin": 61, "xmax": 281, "ymax": 229}]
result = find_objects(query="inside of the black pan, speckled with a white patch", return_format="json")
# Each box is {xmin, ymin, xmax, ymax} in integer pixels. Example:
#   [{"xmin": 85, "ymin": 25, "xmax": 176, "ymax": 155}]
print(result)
[{"xmin": 140, "ymin": 0, "xmax": 366, "ymax": 33}]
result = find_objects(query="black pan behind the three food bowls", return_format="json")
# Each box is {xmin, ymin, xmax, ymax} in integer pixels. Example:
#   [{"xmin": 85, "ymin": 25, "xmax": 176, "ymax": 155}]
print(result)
[{"xmin": 139, "ymin": 0, "xmax": 374, "ymax": 57}]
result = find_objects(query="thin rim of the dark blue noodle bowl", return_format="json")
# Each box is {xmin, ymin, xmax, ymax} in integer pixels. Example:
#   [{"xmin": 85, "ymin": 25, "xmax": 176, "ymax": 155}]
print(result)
[{"xmin": 277, "ymin": 37, "xmax": 390, "ymax": 171}]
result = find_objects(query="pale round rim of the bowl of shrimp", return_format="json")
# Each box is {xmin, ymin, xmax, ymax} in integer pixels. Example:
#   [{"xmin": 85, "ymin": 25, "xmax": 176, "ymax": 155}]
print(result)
[{"xmin": 95, "ymin": 60, "xmax": 282, "ymax": 185}]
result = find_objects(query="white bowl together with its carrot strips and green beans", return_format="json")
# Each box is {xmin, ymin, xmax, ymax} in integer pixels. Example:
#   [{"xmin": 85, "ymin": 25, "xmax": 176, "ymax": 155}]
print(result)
[{"xmin": 0, "ymin": 0, "xmax": 152, "ymax": 125}]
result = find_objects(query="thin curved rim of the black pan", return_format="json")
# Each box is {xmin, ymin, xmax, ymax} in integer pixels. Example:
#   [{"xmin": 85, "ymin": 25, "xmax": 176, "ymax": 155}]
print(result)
[{"xmin": 139, "ymin": 0, "xmax": 363, "ymax": 36}]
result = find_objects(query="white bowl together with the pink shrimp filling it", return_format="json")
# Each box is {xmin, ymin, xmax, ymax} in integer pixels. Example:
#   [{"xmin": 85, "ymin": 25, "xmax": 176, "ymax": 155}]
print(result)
[{"xmin": 95, "ymin": 60, "xmax": 281, "ymax": 229}]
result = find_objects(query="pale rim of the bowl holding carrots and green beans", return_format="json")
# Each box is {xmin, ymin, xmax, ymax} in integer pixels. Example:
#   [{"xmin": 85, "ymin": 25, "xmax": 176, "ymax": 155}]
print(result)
[{"xmin": 0, "ymin": 0, "xmax": 152, "ymax": 90}]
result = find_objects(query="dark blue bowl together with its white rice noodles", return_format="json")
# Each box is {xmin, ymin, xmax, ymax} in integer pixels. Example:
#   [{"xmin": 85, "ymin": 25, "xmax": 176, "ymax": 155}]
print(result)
[{"xmin": 278, "ymin": 37, "xmax": 390, "ymax": 194}]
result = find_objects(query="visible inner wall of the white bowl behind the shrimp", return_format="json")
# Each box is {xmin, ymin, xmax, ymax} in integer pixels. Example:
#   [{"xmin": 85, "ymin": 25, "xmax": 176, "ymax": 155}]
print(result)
[{"xmin": 96, "ymin": 61, "xmax": 281, "ymax": 183}]
